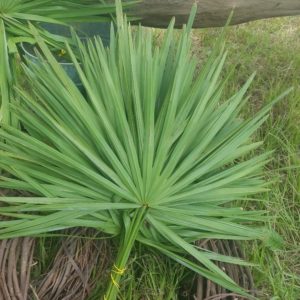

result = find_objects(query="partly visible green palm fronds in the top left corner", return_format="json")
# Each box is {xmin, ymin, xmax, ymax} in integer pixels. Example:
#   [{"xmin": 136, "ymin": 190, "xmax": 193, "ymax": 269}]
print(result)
[{"xmin": 0, "ymin": 0, "xmax": 134, "ymax": 123}]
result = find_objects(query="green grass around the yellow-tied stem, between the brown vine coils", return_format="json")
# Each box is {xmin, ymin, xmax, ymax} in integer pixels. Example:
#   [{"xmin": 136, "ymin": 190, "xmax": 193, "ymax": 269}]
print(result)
[{"xmin": 84, "ymin": 245, "xmax": 189, "ymax": 300}]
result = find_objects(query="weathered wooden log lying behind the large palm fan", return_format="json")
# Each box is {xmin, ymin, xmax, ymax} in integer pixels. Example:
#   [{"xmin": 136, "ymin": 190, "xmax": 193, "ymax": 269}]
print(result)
[{"xmin": 135, "ymin": 0, "xmax": 300, "ymax": 28}]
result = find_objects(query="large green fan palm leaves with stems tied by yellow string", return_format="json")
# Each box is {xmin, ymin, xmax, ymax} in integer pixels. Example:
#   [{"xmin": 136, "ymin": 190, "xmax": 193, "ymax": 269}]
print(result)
[{"xmin": 0, "ymin": 2, "xmax": 288, "ymax": 300}]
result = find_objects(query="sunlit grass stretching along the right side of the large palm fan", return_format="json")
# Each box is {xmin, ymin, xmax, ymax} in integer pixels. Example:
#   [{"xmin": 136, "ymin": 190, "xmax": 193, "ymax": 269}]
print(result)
[{"xmin": 188, "ymin": 17, "xmax": 300, "ymax": 300}]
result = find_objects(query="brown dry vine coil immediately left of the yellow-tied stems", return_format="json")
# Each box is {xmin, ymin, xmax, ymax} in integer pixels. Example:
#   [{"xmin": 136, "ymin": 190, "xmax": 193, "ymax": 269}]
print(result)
[{"xmin": 32, "ymin": 229, "xmax": 110, "ymax": 300}]
